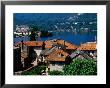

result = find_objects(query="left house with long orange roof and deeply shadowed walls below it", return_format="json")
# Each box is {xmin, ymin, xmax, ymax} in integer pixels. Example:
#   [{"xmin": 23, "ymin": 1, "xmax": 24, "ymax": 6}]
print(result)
[{"xmin": 15, "ymin": 41, "xmax": 43, "ymax": 68}]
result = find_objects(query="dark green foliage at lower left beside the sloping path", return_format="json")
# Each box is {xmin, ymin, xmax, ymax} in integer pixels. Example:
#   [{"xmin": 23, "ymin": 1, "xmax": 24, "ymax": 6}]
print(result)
[{"xmin": 21, "ymin": 66, "xmax": 46, "ymax": 75}]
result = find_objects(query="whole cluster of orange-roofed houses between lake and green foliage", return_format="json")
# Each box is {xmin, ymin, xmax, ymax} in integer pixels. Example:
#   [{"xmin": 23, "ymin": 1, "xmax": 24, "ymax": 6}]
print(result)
[{"xmin": 13, "ymin": 39, "xmax": 97, "ymax": 75}]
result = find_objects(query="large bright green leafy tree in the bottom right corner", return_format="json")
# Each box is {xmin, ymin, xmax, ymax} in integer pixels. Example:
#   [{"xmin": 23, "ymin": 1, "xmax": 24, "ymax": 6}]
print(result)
[{"xmin": 63, "ymin": 59, "xmax": 97, "ymax": 75}]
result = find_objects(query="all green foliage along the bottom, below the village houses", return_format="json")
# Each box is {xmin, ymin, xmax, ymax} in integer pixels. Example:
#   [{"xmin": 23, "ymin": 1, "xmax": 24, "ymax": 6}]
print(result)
[{"xmin": 22, "ymin": 59, "xmax": 97, "ymax": 75}]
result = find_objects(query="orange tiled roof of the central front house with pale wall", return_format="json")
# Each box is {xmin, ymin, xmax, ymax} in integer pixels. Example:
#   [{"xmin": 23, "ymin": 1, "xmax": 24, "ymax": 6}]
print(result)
[{"xmin": 46, "ymin": 50, "xmax": 69, "ymax": 61}]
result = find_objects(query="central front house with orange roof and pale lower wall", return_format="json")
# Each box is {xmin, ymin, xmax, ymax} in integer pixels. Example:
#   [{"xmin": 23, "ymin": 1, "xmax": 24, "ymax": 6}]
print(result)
[{"xmin": 45, "ymin": 49, "xmax": 69, "ymax": 71}]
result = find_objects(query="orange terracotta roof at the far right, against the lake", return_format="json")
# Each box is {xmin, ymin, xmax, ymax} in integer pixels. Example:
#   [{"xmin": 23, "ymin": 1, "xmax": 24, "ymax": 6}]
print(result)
[{"xmin": 77, "ymin": 42, "xmax": 96, "ymax": 50}]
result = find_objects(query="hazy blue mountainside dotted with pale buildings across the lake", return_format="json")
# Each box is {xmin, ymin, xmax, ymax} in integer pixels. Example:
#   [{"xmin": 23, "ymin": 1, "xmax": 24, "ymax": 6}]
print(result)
[{"xmin": 13, "ymin": 13, "xmax": 97, "ymax": 30}]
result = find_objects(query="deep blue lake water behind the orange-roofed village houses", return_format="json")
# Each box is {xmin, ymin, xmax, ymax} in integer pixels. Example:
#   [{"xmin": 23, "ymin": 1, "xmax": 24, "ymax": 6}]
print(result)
[{"xmin": 14, "ymin": 32, "xmax": 96, "ymax": 45}]
